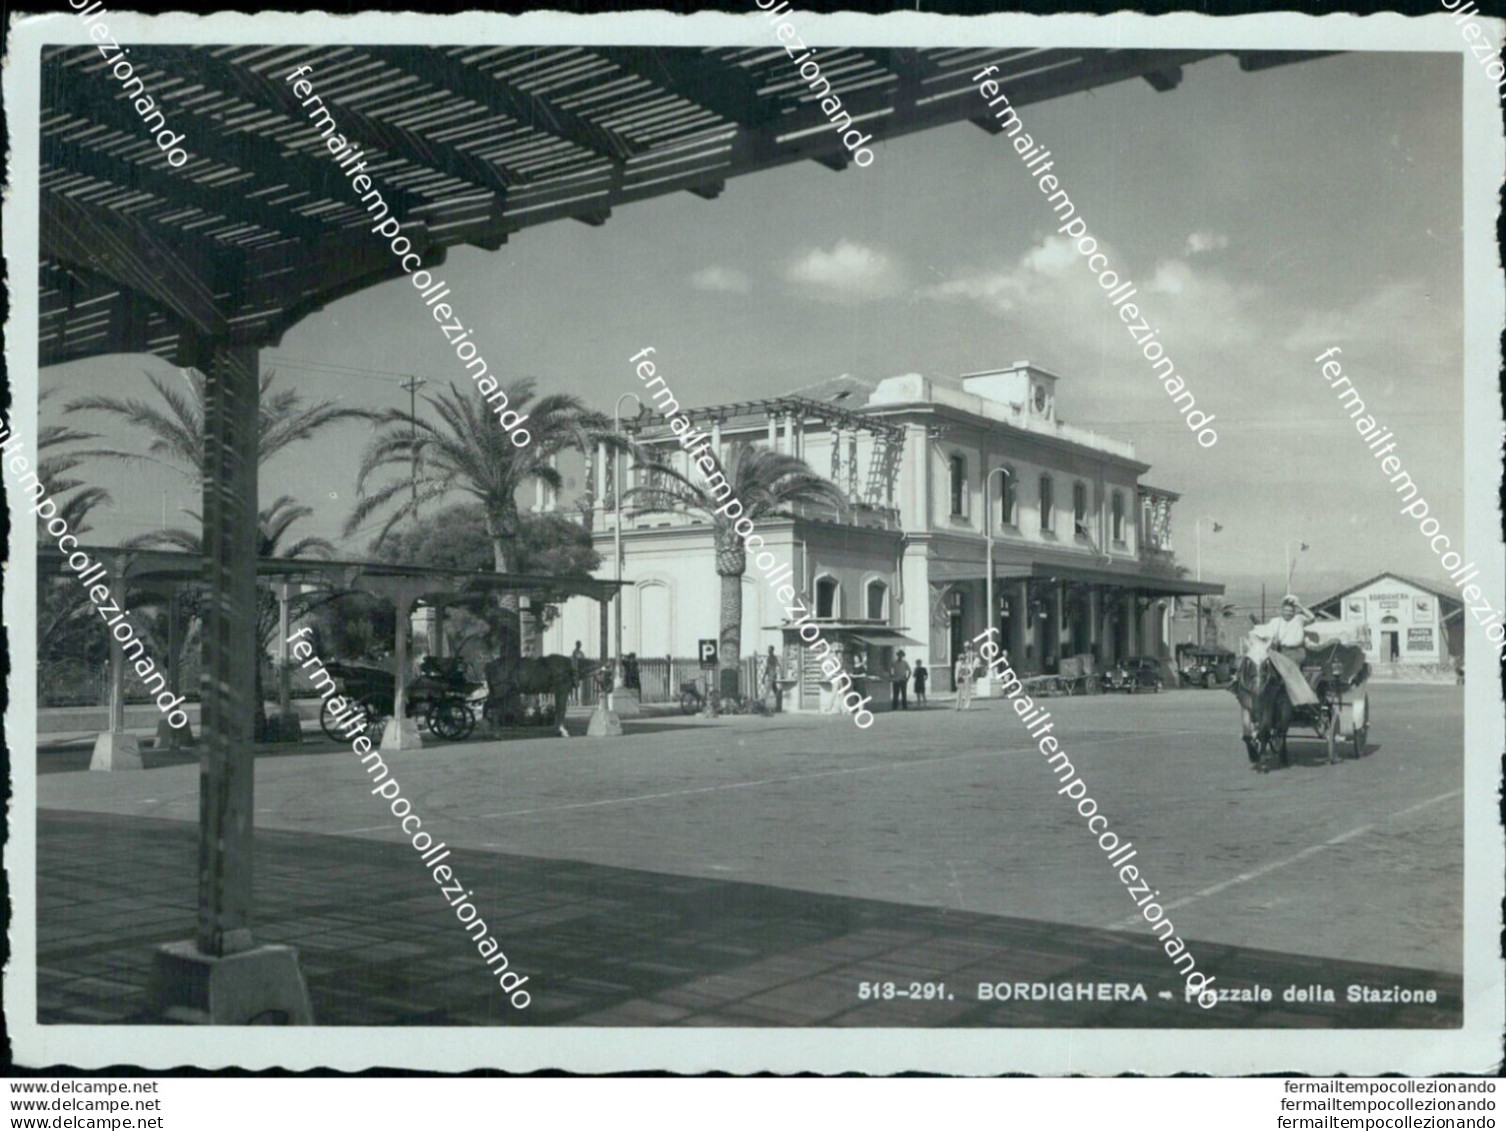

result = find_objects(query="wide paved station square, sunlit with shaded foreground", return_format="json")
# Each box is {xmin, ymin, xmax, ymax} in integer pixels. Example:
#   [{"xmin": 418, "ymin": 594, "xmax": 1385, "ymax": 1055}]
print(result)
[{"xmin": 38, "ymin": 687, "xmax": 1462, "ymax": 1027}]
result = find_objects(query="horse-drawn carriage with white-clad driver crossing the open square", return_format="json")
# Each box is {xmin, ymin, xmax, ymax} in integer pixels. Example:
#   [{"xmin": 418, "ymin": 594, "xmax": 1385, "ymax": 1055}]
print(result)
[{"xmin": 1230, "ymin": 622, "xmax": 1370, "ymax": 773}]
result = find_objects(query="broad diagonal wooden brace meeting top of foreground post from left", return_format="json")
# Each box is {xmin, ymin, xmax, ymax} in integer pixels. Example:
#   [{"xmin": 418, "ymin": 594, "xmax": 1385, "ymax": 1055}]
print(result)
[{"xmin": 39, "ymin": 188, "xmax": 228, "ymax": 337}]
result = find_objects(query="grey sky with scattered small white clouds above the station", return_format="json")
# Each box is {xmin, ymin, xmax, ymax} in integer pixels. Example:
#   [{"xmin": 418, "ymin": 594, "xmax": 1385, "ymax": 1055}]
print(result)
[{"xmin": 42, "ymin": 46, "xmax": 1463, "ymax": 611}]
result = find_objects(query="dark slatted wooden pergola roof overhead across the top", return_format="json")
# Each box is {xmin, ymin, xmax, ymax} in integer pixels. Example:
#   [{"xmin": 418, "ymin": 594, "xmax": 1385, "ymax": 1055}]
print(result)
[{"xmin": 39, "ymin": 45, "xmax": 1325, "ymax": 364}]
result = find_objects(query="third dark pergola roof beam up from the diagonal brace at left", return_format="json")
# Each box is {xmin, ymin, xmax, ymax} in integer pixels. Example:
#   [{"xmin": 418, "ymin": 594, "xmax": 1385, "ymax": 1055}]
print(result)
[{"xmin": 131, "ymin": 45, "xmax": 521, "ymax": 196}]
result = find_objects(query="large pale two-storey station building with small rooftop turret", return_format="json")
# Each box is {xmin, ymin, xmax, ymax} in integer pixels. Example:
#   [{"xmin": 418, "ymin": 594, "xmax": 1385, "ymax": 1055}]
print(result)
[{"xmin": 545, "ymin": 361, "xmax": 1223, "ymax": 690}]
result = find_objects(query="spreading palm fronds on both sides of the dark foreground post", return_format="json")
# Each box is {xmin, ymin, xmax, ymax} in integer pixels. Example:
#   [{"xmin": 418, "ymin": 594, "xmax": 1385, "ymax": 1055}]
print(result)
[{"xmin": 68, "ymin": 369, "xmax": 375, "ymax": 486}]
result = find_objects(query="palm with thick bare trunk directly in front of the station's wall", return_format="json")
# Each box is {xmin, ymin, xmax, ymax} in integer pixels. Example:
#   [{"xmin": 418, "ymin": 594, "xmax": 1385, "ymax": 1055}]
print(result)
[{"xmin": 626, "ymin": 443, "xmax": 848, "ymax": 669}]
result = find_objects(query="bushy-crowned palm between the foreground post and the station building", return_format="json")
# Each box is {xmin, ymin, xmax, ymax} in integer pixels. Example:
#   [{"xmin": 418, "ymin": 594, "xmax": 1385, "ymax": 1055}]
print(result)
[{"xmin": 345, "ymin": 378, "xmax": 625, "ymax": 658}]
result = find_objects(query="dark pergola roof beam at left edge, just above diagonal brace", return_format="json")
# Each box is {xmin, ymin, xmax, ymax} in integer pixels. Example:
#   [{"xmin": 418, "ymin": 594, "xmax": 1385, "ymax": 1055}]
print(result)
[{"xmin": 42, "ymin": 136, "xmax": 330, "ymax": 239}]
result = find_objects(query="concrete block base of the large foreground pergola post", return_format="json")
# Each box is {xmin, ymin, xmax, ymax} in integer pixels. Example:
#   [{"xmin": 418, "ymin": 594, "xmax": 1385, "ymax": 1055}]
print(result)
[{"xmin": 146, "ymin": 940, "xmax": 313, "ymax": 1026}]
